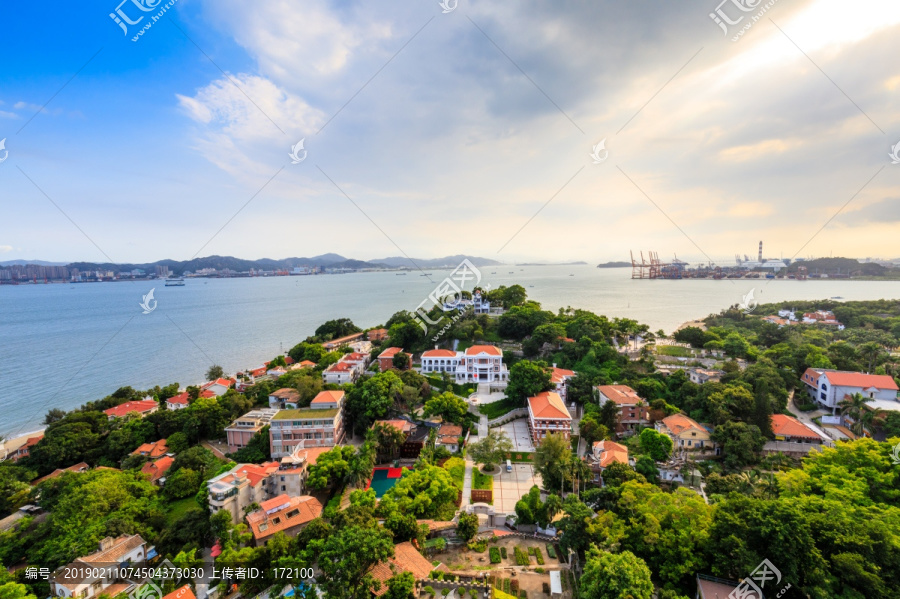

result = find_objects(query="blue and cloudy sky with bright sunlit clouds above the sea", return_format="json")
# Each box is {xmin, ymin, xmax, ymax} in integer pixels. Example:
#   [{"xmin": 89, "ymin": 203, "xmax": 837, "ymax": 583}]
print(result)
[{"xmin": 0, "ymin": 0, "xmax": 900, "ymax": 264}]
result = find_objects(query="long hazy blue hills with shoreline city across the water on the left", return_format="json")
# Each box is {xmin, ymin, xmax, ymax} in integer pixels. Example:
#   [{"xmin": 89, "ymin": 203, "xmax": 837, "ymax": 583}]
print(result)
[{"xmin": 21, "ymin": 253, "xmax": 502, "ymax": 275}]
